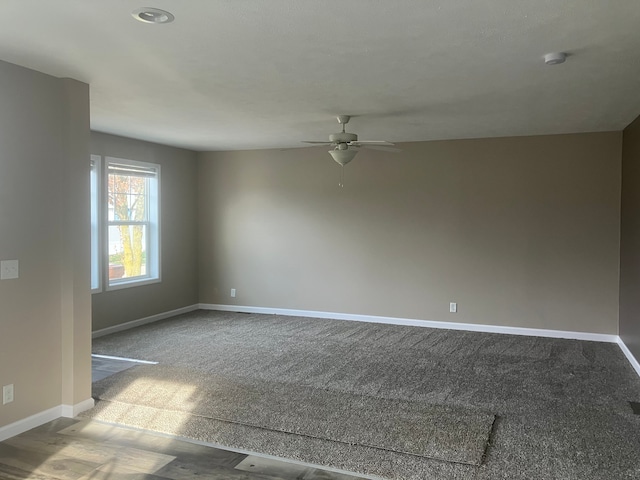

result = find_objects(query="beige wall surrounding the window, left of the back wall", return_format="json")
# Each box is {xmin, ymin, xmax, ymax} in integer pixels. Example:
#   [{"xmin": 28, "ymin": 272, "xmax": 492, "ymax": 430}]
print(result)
[{"xmin": 91, "ymin": 132, "xmax": 198, "ymax": 331}]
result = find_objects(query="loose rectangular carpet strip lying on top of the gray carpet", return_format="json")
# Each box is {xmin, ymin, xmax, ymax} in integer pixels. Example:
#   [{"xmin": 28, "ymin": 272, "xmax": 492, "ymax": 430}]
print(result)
[{"xmin": 87, "ymin": 365, "xmax": 495, "ymax": 465}]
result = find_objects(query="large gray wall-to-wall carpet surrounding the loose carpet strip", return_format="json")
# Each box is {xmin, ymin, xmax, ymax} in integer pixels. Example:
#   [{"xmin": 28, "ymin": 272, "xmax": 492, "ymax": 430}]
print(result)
[{"xmin": 87, "ymin": 311, "xmax": 640, "ymax": 480}]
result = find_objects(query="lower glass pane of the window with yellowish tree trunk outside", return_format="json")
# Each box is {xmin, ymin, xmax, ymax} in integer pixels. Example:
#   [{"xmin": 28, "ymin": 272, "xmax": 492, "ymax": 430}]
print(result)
[{"xmin": 109, "ymin": 225, "xmax": 148, "ymax": 281}]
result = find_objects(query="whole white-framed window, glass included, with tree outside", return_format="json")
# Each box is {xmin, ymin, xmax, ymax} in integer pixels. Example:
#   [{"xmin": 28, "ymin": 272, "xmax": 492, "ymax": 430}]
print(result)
[{"xmin": 91, "ymin": 157, "xmax": 160, "ymax": 291}]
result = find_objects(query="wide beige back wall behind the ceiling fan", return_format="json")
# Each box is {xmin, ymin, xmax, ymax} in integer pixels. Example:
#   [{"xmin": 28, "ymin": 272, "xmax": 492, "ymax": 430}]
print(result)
[{"xmin": 198, "ymin": 132, "xmax": 621, "ymax": 334}]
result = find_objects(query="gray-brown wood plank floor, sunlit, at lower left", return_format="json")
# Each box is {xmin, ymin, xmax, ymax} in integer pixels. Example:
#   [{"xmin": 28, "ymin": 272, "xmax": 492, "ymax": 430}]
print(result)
[{"xmin": 0, "ymin": 358, "xmax": 364, "ymax": 480}]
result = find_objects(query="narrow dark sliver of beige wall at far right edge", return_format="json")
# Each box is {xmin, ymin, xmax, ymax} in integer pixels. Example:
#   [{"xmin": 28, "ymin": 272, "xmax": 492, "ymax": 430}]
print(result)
[{"xmin": 620, "ymin": 117, "xmax": 640, "ymax": 359}]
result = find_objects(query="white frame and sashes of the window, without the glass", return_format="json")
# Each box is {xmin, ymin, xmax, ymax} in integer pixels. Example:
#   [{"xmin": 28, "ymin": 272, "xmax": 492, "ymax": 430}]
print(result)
[{"xmin": 91, "ymin": 155, "xmax": 162, "ymax": 293}]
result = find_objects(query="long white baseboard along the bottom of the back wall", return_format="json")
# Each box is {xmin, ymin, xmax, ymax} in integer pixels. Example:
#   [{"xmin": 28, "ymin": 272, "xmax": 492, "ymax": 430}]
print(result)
[{"xmin": 199, "ymin": 303, "xmax": 618, "ymax": 343}]
